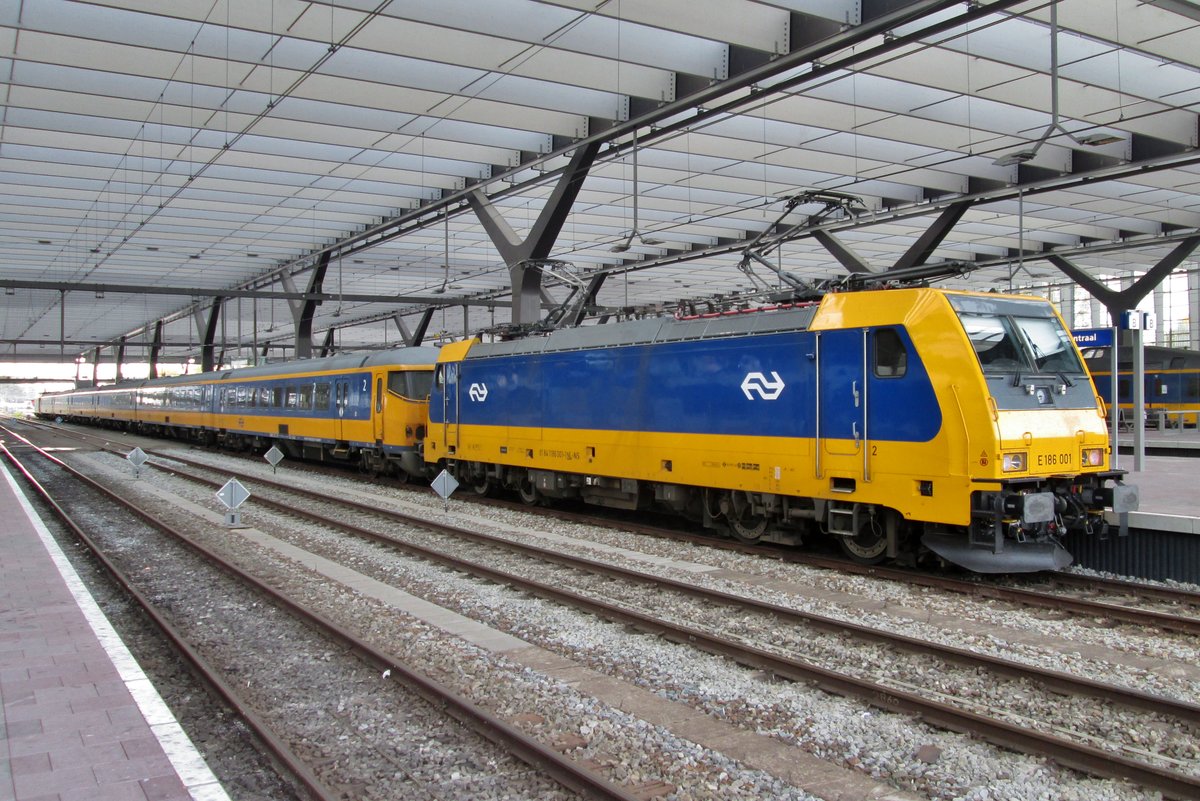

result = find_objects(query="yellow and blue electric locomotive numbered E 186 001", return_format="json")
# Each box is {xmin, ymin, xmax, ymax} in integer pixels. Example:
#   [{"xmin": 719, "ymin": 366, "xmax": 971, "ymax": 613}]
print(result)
[{"xmin": 425, "ymin": 288, "xmax": 1138, "ymax": 572}]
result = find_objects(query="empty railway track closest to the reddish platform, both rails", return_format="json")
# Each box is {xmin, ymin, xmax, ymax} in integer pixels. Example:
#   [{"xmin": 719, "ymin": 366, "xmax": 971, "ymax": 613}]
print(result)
[{"xmin": 0, "ymin": 427, "xmax": 637, "ymax": 801}]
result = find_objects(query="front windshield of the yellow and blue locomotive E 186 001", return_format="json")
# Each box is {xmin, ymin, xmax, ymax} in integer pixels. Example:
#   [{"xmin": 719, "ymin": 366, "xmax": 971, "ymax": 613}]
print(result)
[{"xmin": 959, "ymin": 301, "xmax": 1085, "ymax": 375}]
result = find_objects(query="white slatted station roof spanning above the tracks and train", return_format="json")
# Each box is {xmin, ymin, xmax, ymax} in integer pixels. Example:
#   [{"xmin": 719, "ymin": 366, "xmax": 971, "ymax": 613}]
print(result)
[{"xmin": 0, "ymin": 0, "xmax": 1200, "ymax": 361}]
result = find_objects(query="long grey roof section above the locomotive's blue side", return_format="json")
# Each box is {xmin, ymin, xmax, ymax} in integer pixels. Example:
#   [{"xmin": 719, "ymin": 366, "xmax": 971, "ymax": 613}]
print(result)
[{"xmin": 467, "ymin": 305, "xmax": 816, "ymax": 360}]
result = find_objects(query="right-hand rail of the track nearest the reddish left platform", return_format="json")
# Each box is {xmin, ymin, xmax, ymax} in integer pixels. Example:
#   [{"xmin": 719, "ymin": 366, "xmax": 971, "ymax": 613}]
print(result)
[{"xmin": 0, "ymin": 427, "xmax": 640, "ymax": 801}]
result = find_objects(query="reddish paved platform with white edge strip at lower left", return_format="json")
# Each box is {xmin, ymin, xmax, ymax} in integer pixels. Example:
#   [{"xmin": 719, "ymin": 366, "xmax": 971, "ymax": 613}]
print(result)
[{"xmin": 0, "ymin": 464, "xmax": 228, "ymax": 801}]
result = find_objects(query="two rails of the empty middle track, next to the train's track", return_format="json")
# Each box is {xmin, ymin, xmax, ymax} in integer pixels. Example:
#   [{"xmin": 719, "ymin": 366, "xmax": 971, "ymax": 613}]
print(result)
[{"xmin": 14, "ymin": 422, "xmax": 1200, "ymax": 797}]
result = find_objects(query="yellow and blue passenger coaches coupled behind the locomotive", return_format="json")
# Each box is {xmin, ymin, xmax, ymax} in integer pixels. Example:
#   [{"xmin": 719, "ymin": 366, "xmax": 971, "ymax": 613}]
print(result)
[{"xmin": 37, "ymin": 348, "xmax": 438, "ymax": 477}]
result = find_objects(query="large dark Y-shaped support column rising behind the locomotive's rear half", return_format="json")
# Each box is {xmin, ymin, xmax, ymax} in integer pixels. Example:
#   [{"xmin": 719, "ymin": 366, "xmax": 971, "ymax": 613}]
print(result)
[{"xmin": 470, "ymin": 141, "xmax": 600, "ymax": 324}]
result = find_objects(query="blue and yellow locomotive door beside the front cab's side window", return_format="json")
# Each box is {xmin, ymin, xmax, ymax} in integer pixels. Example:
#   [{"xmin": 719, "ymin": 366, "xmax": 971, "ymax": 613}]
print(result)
[{"xmin": 815, "ymin": 329, "xmax": 868, "ymax": 477}]
